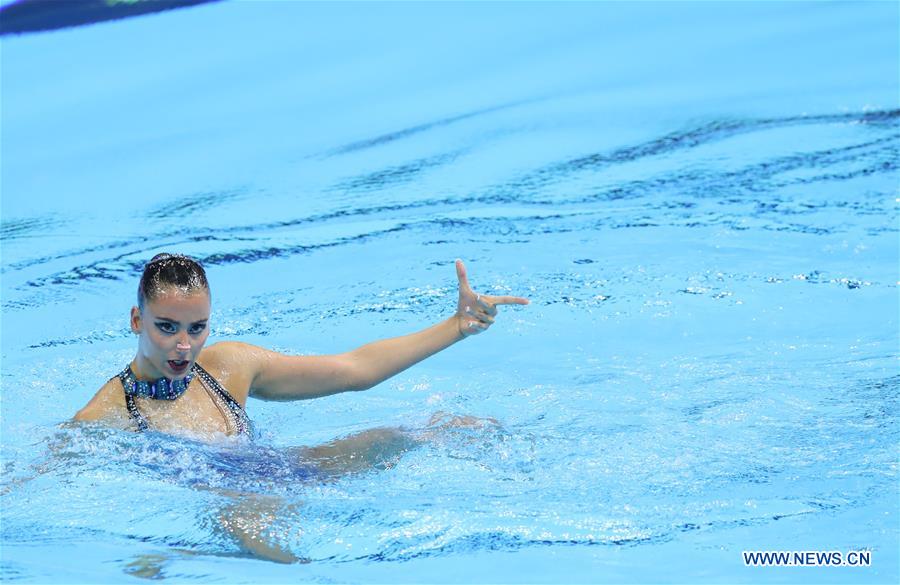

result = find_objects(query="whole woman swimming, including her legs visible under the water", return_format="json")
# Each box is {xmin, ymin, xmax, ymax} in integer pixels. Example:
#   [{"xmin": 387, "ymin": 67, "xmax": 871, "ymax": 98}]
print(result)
[{"xmin": 75, "ymin": 254, "xmax": 528, "ymax": 560}]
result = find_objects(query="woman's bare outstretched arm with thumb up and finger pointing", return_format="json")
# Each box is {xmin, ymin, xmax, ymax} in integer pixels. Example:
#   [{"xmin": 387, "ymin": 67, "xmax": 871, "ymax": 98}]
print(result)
[{"xmin": 233, "ymin": 260, "xmax": 528, "ymax": 400}]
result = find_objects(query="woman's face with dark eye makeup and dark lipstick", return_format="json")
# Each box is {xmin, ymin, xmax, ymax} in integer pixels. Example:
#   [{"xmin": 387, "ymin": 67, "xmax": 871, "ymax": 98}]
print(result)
[{"xmin": 131, "ymin": 287, "xmax": 210, "ymax": 380}]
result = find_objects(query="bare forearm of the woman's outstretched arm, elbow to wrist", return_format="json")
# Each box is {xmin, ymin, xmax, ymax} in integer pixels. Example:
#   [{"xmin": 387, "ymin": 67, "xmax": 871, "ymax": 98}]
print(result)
[{"xmin": 347, "ymin": 315, "xmax": 463, "ymax": 390}]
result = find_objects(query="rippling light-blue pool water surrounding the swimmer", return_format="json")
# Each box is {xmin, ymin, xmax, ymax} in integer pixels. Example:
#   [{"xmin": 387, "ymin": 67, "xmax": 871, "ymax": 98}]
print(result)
[{"xmin": 0, "ymin": 2, "xmax": 900, "ymax": 583}]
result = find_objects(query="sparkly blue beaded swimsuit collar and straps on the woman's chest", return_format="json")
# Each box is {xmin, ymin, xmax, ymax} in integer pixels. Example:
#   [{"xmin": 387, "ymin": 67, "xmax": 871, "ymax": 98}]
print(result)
[{"xmin": 118, "ymin": 362, "xmax": 252, "ymax": 437}]
